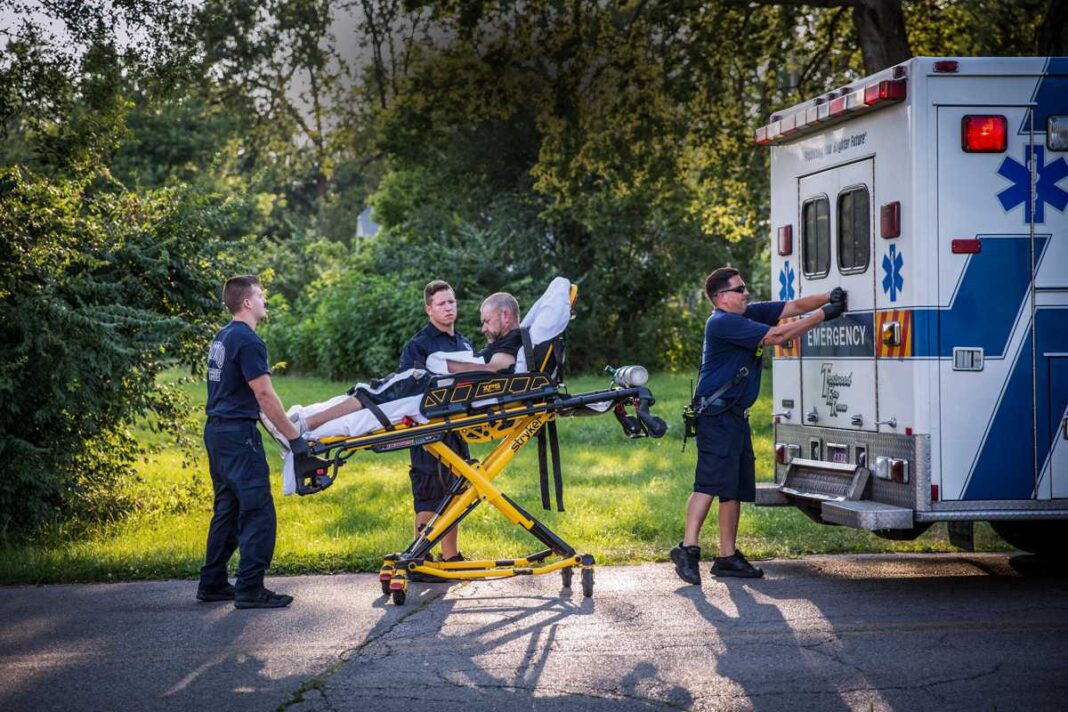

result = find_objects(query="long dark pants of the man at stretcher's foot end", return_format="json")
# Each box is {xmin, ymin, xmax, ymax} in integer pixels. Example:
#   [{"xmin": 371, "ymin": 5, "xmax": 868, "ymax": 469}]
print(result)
[{"xmin": 201, "ymin": 418, "xmax": 277, "ymax": 592}]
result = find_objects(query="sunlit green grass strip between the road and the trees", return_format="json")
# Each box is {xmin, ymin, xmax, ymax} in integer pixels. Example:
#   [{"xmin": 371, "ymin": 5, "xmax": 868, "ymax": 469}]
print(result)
[{"xmin": 0, "ymin": 374, "xmax": 1005, "ymax": 583}]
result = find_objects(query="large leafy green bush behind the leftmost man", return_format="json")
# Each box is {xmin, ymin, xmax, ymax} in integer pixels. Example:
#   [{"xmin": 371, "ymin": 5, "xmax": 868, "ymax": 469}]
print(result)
[{"xmin": 0, "ymin": 169, "xmax": 236, "ymax": 536}]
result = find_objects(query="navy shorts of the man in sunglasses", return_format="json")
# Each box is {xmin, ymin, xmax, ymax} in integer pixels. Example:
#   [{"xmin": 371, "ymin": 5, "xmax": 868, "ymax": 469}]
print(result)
[{"xmin": 693, "ymin": 412, "xmax": 756, "ymax": 502}]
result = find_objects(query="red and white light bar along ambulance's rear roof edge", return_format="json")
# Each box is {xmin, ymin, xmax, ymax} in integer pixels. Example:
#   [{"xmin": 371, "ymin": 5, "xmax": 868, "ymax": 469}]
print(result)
[{"xmin": 753, "ymin": 78, "xmax": 908, "ymax": 146}]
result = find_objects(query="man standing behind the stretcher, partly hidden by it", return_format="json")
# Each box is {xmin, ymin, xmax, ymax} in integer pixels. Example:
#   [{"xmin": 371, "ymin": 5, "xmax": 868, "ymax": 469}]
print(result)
[{"xmin": 398, "ymin": 280, "xmax": 474, "ymax": 560}]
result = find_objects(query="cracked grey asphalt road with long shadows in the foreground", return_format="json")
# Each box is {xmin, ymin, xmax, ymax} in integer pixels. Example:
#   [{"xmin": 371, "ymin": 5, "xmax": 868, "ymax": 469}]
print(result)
[{"xmin": 0, "ymin": 554, "xmax": 1068, "ymax": 712}]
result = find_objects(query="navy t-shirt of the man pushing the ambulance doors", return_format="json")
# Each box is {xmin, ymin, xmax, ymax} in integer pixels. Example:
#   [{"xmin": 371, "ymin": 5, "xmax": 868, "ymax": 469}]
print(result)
[{"xmin": 695, "ymin": 302, "xmax": 786, "ymax": 408}]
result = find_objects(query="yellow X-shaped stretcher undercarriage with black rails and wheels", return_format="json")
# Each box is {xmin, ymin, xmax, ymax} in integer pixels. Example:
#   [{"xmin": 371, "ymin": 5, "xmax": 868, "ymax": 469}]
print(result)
[{"xmin": 297, "ymin": 382, "xmax": 666, "ymax": 605}]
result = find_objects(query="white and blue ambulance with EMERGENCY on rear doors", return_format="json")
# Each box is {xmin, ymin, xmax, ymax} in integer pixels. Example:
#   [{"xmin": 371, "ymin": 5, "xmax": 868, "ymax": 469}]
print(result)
[{"xmin": 756, "ymin": 58, "xmax": 1068, "ymax": 551}]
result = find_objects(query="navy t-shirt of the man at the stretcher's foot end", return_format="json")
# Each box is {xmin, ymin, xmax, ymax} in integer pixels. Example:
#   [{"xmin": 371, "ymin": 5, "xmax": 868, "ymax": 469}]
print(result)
[{"xmin": 205, "ymin": 321, "xmax": 270, "ymax": 420}]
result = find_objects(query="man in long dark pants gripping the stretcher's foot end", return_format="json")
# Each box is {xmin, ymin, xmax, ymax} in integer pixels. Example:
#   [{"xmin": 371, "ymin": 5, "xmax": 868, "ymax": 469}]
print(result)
[{"xmin": 197, "ymin": 274, "xmax": 308, "ymax": 608}]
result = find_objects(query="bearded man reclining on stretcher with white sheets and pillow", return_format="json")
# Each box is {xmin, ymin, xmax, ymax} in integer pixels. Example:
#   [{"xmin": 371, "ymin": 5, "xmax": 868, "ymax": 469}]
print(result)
[{"xmin": 261, "ymin": 278, "xmax": 571, "ymax": 494}]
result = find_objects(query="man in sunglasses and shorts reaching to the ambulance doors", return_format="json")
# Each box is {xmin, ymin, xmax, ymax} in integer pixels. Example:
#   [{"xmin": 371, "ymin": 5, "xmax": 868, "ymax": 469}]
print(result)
[{"xmin": 671, "ymin": 267, "xmax": 846, "ymax": 584}]
